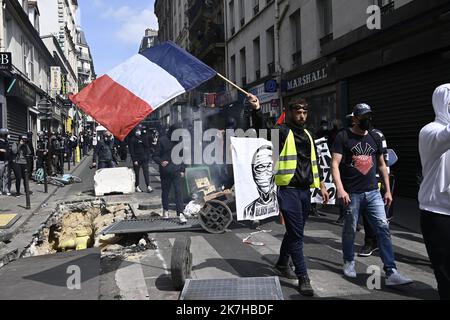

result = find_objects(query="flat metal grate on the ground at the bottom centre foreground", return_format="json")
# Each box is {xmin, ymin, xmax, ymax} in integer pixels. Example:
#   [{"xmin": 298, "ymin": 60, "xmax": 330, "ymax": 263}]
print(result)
[{"xmin": 180, "ymin": 277, "xmax": 284, "ymax": 300}]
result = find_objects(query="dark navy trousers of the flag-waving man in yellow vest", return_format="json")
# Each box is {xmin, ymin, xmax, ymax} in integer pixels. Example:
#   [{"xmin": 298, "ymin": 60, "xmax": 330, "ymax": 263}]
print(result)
[{"xmin": 277, "ymin": 188, "xmax": 311, "ymax": 278}]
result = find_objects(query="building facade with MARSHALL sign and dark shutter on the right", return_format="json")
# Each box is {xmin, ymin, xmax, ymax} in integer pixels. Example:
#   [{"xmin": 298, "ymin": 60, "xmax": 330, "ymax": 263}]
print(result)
[{"xmin": 224, "ymin": 0, "xmax": 450, "ymax": 197}]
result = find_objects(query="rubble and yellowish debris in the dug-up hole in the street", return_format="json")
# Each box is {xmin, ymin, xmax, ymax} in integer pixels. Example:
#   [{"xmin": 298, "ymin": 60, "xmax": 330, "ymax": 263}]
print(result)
[{"xmin": 23, "ymin": 199, "xmax": 155, "ymax": 257}]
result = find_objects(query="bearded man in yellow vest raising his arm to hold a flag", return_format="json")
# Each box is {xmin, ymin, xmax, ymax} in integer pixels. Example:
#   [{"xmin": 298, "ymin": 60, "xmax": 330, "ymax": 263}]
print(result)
[{"xmin": 247, "ymin": 95, "xmax": 329, "ymax": 296}]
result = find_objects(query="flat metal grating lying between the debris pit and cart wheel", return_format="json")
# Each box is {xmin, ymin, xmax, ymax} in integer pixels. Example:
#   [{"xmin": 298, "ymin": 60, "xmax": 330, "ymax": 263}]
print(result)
[{"xmin": 102, "ymin": 218, "xmax": 203, "ymax": 234}]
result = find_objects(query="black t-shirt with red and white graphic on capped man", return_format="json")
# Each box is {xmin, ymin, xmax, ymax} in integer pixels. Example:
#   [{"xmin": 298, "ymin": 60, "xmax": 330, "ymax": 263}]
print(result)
[{"xmin": 332, "ymin": 130, "xmax": 383, "ymax": 193}]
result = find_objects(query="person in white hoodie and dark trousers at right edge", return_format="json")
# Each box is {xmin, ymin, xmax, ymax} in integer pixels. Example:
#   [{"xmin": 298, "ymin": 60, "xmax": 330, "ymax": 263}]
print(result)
[{"xmin": 419, "ymin": 84, "xmax": 450, "ymax": 300}]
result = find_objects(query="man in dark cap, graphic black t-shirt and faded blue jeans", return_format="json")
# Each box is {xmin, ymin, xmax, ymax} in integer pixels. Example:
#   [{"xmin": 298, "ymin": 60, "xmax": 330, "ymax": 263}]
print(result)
[{"xmin": 332, "ymin": 104, "xmax": 412, "ymax": 286}]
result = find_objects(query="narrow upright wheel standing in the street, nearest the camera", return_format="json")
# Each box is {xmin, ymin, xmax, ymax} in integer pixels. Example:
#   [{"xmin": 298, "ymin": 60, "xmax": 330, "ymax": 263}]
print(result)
[{"xmin": 170, "ymin": 237, "xmax": 192, "ymax": 291}]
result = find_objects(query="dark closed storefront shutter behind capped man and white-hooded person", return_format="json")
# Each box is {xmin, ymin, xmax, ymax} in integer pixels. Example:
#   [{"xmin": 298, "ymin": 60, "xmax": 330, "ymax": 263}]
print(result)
[{"xmin": 348, "ymin": 53, "xmax": 450, "ymax": 198}]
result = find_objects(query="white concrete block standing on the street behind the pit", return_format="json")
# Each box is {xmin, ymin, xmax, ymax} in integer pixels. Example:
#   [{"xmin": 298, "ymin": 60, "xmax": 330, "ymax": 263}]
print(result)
[{"xmin": 94, "ymin": 168, "xmax": 136, "ymax": 196}]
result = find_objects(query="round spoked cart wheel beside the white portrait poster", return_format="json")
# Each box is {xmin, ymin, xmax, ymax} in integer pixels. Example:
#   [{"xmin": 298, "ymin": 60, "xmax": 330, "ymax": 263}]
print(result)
[{"xmin": 198, "ymin": 200, "xmax": 233, "ymax": 234}]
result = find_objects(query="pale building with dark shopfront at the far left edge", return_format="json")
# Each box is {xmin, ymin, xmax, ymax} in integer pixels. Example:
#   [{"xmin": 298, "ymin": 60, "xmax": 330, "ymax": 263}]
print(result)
[{"xmin": 0, "ymin": 0, "xmax": 55, "ymax": 139}]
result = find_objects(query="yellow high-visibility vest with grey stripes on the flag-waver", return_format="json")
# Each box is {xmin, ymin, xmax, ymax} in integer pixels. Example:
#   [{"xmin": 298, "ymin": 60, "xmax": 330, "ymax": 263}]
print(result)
[{"xmin": 275, "ymin": 130, "xmax": 320, "ymax": 188}]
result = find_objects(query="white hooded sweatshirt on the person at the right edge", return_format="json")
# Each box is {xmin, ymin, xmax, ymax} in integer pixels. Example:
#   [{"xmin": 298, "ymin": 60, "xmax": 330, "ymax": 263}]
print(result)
[{"xmin": 419, "ymin": 84, "xmax": 450, "ymax": 216}]
